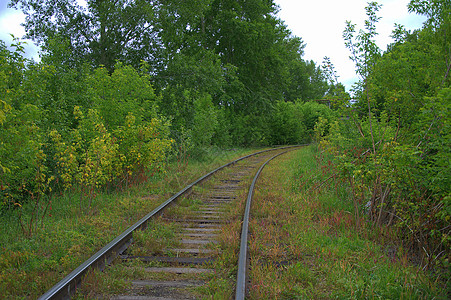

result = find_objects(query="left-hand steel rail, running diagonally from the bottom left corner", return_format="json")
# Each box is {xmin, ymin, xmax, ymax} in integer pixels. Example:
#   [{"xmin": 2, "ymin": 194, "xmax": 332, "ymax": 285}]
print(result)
[{"xmin": 38, "ymin": 146, "xmax": 299, "ymax": 300}]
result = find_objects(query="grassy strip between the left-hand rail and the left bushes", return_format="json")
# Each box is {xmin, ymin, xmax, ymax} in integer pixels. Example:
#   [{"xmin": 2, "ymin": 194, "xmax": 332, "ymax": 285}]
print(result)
[{"xmin": 0, "ymin": 149, "xmax": 252, "ymax": 299}]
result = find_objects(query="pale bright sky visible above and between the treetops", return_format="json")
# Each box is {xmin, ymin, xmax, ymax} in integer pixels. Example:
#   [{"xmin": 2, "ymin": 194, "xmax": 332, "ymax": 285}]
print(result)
[{"xmin": 0, "ymin": 0, "xmax": 425, "ymax": 90}]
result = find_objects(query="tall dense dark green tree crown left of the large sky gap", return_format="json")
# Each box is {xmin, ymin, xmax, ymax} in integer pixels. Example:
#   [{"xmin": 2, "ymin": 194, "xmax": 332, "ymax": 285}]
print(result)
[{"xmin": 156, "ymin": 0, "xmax": 327, "ymax": 116}]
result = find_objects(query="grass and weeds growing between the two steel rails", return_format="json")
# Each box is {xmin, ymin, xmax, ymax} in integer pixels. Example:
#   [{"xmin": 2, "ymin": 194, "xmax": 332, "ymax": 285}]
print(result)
[{"xmin": 77, "ymin": 154, "xmax": 256, "ymax": 299}]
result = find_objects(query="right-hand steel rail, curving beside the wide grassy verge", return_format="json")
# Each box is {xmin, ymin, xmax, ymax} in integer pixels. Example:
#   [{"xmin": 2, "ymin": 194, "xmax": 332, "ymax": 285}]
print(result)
[{"xmin": 235, "ymin": 150, "xmax": 289, "ymax": 300}]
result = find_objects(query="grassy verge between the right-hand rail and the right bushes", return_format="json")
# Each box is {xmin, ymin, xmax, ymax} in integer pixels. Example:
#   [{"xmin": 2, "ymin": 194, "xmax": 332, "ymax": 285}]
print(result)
[{"xmin": 249, "ymin": 146, "xmax": 448, "ymax": 299}]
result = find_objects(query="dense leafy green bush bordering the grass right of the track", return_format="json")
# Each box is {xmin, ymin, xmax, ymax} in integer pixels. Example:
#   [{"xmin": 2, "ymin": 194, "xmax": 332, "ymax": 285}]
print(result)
[{"xmin": 321, "ymin": 88, "xmax": 451, "ymax": 265}]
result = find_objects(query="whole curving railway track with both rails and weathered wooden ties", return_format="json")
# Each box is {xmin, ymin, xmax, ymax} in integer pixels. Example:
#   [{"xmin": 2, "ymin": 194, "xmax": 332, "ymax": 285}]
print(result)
[{"xmin": 40, "ymin": 147, "xmax": 300, "ymax": 300}]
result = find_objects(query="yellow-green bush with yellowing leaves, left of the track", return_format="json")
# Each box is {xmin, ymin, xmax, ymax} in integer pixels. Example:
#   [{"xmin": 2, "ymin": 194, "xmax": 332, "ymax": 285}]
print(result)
[{"xmin": 50, "ymin": 107, "xmax": 172, "ymax": 199}]
